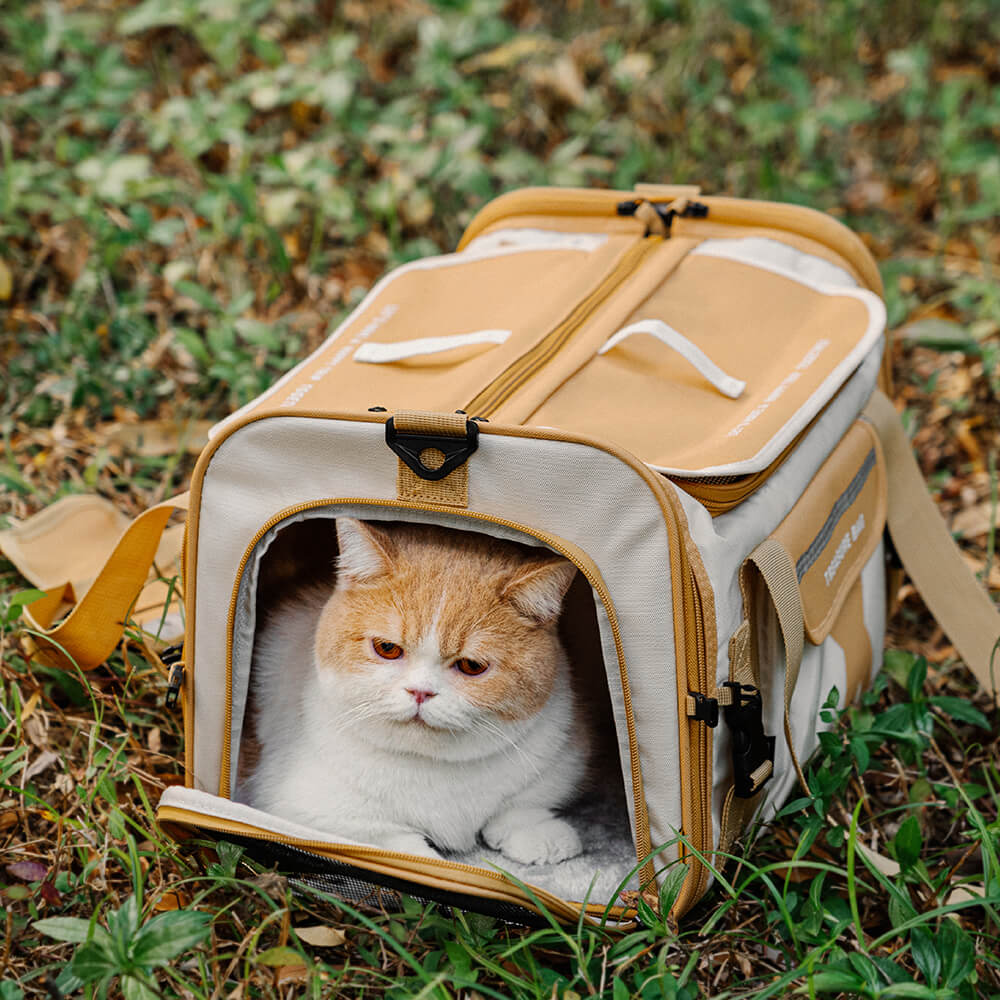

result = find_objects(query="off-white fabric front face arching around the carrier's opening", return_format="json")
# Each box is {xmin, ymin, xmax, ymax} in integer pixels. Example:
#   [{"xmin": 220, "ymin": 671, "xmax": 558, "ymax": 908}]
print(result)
[{"xmin": 193, "ymin": 417, "xmax": 681, "ymax": 868}]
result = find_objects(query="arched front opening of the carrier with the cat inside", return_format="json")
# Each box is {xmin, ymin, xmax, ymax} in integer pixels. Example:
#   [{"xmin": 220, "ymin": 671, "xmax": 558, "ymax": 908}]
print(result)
[{"xmin": 220, "ymin": 503, "xmax": 645, "ymax": 905}]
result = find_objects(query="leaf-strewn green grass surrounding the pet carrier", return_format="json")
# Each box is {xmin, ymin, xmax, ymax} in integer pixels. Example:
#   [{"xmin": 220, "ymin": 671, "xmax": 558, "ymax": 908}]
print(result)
[{"xmin": 0, "ymin": 0, "xmax": 1000, "ymax": 1000}]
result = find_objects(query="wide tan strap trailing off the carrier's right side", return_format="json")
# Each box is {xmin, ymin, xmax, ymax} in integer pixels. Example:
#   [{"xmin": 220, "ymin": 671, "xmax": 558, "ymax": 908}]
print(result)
[{"xmin": 864, "ymin": 389, "xmax": 1000, "ymax": 701}]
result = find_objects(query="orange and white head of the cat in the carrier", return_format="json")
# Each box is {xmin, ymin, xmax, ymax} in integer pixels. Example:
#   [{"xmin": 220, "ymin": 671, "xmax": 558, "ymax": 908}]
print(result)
[{"xmin": 315, "ymin": 518, "xmax": 576, "ymax": 759}]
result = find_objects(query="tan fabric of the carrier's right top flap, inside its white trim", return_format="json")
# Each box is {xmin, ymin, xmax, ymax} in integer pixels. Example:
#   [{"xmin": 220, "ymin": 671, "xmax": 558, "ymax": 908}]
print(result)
[{"xmin": 531, "ymin": 252, "xmax": 872, "ymax": 474}]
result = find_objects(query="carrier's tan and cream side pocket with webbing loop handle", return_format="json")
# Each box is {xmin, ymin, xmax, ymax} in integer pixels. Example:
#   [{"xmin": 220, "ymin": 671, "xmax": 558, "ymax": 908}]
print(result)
[{"xmin": 720, "ymin": 420, "xmax": 887, "ymax": 849}]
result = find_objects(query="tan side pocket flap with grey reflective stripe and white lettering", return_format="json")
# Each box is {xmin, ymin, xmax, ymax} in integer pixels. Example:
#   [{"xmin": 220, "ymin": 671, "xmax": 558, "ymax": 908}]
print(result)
[{"xmin": 774, "ymin": 420, "xmax": 888, "ymax": 640}]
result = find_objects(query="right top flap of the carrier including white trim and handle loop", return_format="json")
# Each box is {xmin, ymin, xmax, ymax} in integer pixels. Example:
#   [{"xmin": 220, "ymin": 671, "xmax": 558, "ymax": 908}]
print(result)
[{"xmin": 528, "ymin": 235, "xmax": 885, "ymax": 478}]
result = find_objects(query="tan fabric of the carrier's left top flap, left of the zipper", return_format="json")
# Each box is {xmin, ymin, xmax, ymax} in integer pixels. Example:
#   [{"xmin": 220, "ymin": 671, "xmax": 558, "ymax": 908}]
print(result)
[{"xmin": 230, "ymin": 235, "xmax": 635, "ymax": 416}]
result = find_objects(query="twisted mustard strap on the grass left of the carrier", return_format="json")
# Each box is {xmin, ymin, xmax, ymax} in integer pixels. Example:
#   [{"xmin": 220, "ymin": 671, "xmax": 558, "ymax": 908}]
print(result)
[{"xmin": 24, "ymin": 493, "xmax": 189, "ymax": 670}]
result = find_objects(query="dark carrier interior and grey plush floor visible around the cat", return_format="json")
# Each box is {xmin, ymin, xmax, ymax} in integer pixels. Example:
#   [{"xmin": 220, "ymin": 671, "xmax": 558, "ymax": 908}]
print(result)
[{"xmin": 229, "ymin": 505, "xmax": 638, "ymax": 904}]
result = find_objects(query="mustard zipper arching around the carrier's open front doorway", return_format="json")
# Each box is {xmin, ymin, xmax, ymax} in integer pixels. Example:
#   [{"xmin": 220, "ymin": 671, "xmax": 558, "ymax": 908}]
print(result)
[{"xmin": 219, "ymin": 498, "xmax": 653, "ymax": 882}]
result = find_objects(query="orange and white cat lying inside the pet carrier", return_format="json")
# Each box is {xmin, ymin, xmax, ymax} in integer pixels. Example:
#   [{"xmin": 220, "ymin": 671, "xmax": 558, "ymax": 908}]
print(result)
[{"xmin": 236, "ymin": 517, "xmax": 588, "ymax": 865}]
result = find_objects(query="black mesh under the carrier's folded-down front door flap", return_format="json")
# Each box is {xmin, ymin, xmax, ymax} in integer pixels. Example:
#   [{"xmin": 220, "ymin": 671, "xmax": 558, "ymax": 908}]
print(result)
[{"xmin": 226, "ymin": 834, "xmax": 549, "ymax": 927}]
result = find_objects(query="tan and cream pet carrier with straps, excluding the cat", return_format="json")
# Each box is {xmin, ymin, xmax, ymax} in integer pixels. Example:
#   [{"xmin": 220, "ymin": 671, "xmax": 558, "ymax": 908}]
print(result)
[{"xmin": 7, "ymin": 185, "xmax": 1000, "ymax": 921}]
